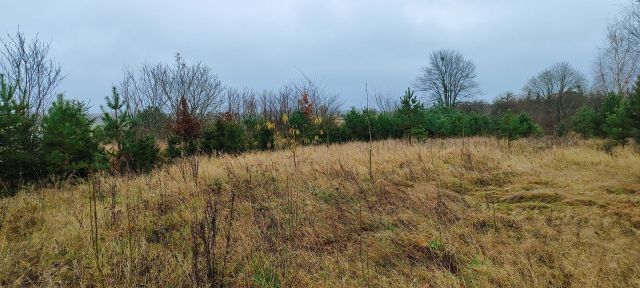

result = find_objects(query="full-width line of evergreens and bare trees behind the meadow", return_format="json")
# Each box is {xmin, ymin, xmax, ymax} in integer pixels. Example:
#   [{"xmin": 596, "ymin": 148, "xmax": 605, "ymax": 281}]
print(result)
[{"xmin": 0, "ymin": 3, "xmax": 640, "ymax": 194}]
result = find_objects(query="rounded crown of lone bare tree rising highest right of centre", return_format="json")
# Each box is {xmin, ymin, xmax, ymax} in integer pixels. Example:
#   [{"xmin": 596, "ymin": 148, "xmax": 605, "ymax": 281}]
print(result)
[{"xmin": 415, "ymin": 50, "xmax": 480, "ymax": 107}]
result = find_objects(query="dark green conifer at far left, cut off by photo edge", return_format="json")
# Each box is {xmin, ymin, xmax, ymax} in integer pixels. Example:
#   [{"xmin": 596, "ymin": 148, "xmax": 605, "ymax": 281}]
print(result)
[{"xmin": 0, "ymin": 75, "xmax": 40, "ymax": 196}]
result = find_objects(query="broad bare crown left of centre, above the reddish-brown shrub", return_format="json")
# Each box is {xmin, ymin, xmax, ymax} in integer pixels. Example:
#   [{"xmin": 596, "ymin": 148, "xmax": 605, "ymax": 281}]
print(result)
[{"xmin": 120, "ymin": 54, "xmax": 224, "ymax": 120}]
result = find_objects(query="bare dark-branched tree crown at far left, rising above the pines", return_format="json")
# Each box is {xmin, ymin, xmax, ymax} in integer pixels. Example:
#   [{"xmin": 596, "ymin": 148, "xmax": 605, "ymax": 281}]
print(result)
[{"xmin": 0, "ymin": 32, "xmax": 65, "ymax": 115}]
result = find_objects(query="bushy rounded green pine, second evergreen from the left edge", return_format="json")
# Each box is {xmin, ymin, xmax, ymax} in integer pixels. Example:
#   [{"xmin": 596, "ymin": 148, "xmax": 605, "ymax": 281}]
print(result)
[{"xmin": 41, "ymin": 95, "xmax": 104, "ymax": 177}]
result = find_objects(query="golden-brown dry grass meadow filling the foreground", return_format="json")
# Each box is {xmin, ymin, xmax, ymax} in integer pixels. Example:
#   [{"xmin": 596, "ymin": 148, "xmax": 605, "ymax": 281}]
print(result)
[{"xmin": 0, "ymin": 138, "xmax": 640, "ymax": 287}]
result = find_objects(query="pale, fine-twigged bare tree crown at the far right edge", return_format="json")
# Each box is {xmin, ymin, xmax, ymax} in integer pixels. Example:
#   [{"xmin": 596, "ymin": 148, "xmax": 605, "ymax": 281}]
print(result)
[{"xmin": 593, "ymin": 23, "xmax": 640, "ymax": 95}]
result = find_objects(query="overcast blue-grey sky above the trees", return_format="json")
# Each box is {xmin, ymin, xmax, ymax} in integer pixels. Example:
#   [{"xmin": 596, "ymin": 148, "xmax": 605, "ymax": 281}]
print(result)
[{"xmin": 0, "ymin": 0, "xmax": 625, "ymax": 109}]
